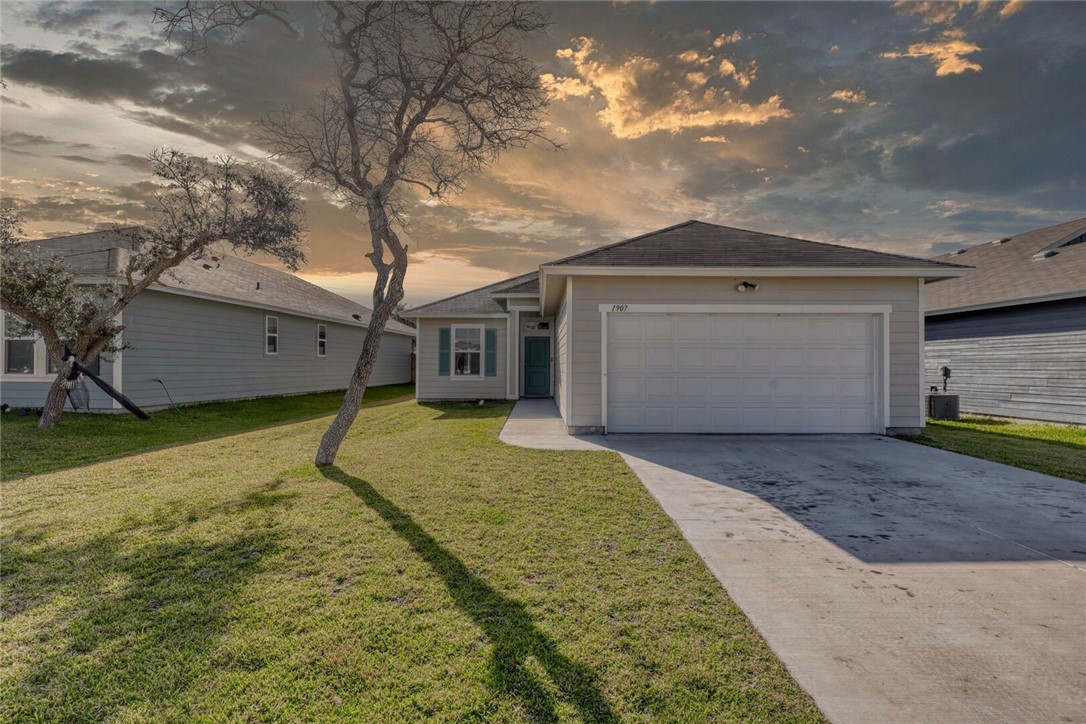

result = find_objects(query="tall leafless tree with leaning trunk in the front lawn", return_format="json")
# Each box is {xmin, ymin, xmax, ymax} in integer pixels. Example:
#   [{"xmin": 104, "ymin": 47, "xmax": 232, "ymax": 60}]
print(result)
[{"xmin": 157, "ymin": 1, "xmax": 547, "ymax": 467}]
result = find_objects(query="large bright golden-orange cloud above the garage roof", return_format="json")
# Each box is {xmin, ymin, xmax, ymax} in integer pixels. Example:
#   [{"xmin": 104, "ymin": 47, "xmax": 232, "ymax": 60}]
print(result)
[{"xmin": 545, "ymin": 37, "xmax": 792, "ymax": 139}]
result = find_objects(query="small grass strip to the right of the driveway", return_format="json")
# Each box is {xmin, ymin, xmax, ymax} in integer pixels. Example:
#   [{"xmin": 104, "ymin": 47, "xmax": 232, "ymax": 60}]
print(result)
[{"xmin": 909, "ymin": 417, "xmax": 1086, "ymax": 483}]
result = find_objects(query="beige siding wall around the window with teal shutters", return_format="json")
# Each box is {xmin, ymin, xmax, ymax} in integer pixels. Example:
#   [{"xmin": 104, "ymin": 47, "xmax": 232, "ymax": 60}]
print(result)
[{"xmin": 415, "ymin": 317, "xmax": 508, "ymax": 399}]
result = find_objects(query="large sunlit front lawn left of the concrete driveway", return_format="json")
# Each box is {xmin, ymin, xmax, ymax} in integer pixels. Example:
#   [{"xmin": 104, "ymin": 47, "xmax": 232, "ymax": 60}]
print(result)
[{"xmin": 0, "ymin": 402, "xmax": 821, "ymax": 722}]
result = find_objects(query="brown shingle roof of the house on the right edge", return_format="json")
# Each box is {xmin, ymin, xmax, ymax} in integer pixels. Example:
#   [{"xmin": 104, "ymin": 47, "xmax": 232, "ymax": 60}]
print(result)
[{"xmin": 924, "ymin": 218, "xmax": 1086, "ymax": 313}]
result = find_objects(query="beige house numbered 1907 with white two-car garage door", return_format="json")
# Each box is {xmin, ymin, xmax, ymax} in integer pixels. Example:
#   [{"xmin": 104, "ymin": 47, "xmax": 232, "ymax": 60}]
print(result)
[{"xmin": 404, "ymin": 221, "xmax": 968, "ymax": 433}]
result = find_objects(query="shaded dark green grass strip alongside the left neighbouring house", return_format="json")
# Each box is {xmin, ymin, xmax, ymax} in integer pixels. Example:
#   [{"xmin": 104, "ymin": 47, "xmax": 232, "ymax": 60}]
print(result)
[{"xmin": 0, "ymin": 384, "xmax": 415, "ymax": 479}]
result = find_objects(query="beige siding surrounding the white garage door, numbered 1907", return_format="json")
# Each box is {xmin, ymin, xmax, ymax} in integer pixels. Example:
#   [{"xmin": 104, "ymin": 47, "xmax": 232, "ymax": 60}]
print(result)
[{"xmin": 568, "ymin": 276, "xmax": 924, "ymax": 428}]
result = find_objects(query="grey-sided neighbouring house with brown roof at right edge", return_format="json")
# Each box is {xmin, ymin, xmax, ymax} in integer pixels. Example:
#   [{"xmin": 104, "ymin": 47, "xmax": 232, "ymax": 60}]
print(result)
[{"xmin": 924, "ymin": 218, "xmax": 1086, "ymax": 424}]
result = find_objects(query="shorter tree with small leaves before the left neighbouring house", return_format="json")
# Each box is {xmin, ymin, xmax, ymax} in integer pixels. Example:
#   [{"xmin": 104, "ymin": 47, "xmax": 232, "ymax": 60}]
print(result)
[{"xmin": 0, "ymin": 149, "xmax": 304, "ymax": 428}]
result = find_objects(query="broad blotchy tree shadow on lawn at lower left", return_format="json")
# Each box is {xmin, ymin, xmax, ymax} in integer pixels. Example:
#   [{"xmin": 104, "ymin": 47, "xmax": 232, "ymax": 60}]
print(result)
[{"xmin": 0, "ymin": 483, "xmax": 291, "ymax": 721}]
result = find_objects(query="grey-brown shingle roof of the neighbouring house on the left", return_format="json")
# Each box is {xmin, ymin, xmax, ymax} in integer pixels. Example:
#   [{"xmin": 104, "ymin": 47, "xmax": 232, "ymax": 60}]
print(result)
[{"xmin": 28, "ymin": 231, "xmax": 415, "ymax": 335}]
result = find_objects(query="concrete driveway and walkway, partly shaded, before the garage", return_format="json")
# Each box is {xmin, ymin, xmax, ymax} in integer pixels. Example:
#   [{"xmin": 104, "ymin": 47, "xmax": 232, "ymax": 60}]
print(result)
[{"xmin": 502, "ymin": 402, "xmax": 1086, "ymax": 723}]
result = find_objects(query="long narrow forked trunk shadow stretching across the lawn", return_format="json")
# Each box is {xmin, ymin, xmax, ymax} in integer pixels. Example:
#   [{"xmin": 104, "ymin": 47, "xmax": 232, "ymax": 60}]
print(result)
[{"xmin": 321, "ymin": 467, "xmax": 618, "ymax": 722}]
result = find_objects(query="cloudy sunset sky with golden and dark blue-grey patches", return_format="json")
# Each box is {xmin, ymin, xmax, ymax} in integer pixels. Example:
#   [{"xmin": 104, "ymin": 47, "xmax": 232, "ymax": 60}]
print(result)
[{"xmin": 0, "ymin": 2, "xmax": 1086, "ymax": 304}]
